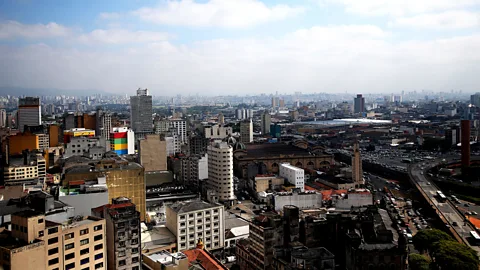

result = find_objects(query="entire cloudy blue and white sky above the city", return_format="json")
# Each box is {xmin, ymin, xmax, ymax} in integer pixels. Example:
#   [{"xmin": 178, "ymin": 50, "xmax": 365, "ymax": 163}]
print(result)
[{"xmin": 0, "ymin": 0, "xmax": 480, "ymax": 95}]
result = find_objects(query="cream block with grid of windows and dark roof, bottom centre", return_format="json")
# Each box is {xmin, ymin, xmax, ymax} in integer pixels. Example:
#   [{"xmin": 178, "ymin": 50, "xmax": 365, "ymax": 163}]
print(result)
[{"xmin": 166, "ymin": 201, "xmax": 225, "ymax": 251}]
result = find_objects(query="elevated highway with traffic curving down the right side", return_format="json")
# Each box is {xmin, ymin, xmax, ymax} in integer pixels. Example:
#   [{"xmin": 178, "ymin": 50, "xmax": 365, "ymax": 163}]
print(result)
[{"xmin": 408, "ymin": 157, "xmax": 480, "ymax": 256}]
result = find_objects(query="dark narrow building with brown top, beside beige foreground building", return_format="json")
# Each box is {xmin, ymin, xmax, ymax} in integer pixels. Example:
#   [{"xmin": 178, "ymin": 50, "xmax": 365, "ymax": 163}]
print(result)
[{"xmin": 92, "ymin": 197, "xmax": 142, "ymax": 270}]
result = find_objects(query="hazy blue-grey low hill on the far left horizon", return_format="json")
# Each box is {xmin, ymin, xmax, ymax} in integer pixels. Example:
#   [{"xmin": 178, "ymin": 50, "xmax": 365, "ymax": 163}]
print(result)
[{"xmin": 0, "ymin": 86, "xmax": 112, "ymax": 96}]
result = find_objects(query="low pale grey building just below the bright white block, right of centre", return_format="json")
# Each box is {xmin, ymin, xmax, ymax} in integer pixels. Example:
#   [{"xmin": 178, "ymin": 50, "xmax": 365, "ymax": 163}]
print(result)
[{"xmin": 273, "ymin": 191, "xmax": 322, "ymax": 211}]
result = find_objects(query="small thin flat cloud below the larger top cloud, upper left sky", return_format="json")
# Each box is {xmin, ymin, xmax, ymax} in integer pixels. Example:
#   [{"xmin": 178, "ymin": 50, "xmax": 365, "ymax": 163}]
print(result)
[{"xmin": 78, "ymin": 29, "xmax": 170, "ymax": 45}]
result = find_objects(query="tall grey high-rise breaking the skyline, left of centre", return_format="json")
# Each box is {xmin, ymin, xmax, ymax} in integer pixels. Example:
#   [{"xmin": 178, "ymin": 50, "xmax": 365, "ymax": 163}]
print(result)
[{"xmin": 130, "ymin": 88, "xmax": 153, "ymax": 138}]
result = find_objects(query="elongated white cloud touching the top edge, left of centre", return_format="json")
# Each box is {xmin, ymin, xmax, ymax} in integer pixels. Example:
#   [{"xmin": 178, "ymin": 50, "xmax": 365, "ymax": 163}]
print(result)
[{"xmin": 133, "ymin": 0, "xmax": 304, "ymax": 28}]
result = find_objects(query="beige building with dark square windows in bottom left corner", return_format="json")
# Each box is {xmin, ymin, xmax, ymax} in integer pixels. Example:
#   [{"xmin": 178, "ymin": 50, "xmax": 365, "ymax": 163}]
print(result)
[{"xmin": 0, "ymin": 210, "xmax": 106, "ymax": 270}]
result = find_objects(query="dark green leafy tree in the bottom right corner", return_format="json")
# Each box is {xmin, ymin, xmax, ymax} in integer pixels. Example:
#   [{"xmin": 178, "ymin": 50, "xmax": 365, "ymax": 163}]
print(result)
[{"xmin": 432, "ymin": 240, "xmax": 479, "ymax": 270}]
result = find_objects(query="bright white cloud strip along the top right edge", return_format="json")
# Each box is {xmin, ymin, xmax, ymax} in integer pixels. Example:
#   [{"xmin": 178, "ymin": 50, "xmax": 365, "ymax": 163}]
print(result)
[{"xmin": 326, "ymin": 0, "xmax": 480, "ymax": 16}]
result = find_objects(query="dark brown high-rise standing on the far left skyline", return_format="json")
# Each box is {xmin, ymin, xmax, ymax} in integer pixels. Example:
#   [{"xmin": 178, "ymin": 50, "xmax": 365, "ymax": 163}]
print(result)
[{"xmin": 17, "ymin": 97, "xmax": 42, "ymax": 132}]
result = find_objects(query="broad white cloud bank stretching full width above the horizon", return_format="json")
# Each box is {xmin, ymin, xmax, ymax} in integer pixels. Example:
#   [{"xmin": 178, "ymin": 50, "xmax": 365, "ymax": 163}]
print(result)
[{"xmin": 0, "ymin": 25, "xmax": 480, "ymax": 95}]
